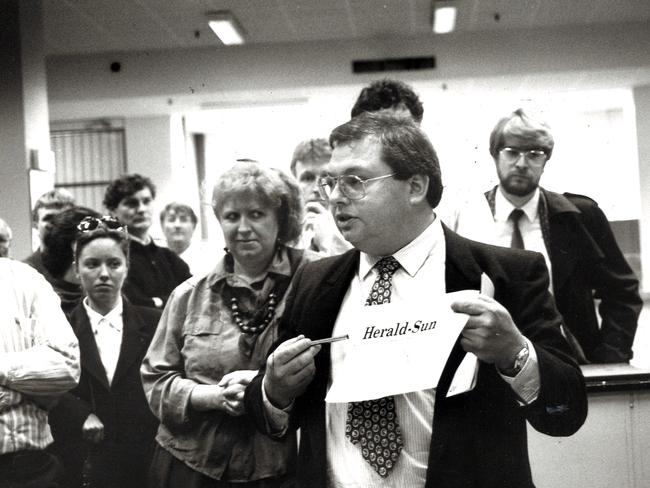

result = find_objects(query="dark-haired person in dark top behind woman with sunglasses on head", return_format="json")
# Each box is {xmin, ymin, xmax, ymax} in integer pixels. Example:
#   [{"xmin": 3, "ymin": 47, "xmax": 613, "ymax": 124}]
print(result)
[{"xmin": 104, "ymin": 174, "xmax": 191, "ymax": 308}]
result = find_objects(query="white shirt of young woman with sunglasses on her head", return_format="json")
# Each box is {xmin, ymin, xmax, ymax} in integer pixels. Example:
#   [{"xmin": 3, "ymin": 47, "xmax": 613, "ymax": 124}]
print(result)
[{"xmin": 83, "ymin": 297, "xmax": 124, "ymax": 385}]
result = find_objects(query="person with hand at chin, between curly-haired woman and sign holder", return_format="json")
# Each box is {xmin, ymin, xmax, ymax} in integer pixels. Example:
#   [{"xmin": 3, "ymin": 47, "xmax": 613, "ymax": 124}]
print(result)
[{"xmin": 291, "ymin": 135, "xmax": 350, "ymax": 256}]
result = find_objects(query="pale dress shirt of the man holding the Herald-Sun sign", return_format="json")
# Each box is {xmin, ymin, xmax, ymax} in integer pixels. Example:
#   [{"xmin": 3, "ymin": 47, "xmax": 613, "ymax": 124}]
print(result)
[{"xmin": 263, "ymin": 220, "xmax": 539, "ymax": 488}]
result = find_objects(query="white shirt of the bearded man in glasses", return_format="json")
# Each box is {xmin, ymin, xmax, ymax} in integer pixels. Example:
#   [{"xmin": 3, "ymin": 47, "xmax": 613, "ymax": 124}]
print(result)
[{"xmin": 494, "ymin": 187, "xmax": 553, "ymax": 293}]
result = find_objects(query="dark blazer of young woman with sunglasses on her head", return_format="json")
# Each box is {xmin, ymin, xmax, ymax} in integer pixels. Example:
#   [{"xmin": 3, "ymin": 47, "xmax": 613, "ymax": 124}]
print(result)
[{"xmin": 50, "ymin": 299, "xmax": 160, "ymax": 488}]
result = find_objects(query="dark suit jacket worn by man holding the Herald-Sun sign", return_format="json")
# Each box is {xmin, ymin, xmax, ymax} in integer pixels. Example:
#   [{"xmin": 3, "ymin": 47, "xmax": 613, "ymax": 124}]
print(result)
[{"xmin": 245, "ymin": 228, "xmax": 587, "ymax": 488}]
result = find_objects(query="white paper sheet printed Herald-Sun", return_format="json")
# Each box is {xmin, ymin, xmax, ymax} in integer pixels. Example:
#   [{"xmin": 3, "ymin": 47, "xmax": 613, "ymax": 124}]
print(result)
[{"xmin": 325, "ymin": 290, "xmax": 470, "ymax": 403}]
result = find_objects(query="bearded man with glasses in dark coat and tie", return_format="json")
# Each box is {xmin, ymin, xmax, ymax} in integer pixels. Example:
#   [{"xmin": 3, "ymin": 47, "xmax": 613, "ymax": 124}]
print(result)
[{"xmin": 486, "ymin": 109, "xmax": 643, "ymax": 363}]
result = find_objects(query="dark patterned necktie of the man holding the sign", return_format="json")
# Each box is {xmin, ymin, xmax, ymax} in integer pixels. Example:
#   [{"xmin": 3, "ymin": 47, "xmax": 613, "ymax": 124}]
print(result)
[{"xmin": 345, "ymin": 256, "xmax": 403, "ymax": 478}]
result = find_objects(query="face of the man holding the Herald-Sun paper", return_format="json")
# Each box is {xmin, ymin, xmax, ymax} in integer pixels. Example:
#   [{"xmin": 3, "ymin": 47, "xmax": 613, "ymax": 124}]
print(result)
[{"xmin": 327, "ymin": 138, "xmax": 411, "ymax": 256}]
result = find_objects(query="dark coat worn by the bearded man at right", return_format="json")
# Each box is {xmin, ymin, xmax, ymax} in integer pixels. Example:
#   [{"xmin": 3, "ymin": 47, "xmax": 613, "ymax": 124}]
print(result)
[{"xmin": 541, "ymin": 189, "xmax": 643, "ymax": 362}]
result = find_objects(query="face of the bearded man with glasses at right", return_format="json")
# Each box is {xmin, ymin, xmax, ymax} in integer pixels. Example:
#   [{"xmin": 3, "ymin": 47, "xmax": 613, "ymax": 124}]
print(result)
[{"xmin": 494, "ymin": 136, "xmax": 546, "ymax": 197}]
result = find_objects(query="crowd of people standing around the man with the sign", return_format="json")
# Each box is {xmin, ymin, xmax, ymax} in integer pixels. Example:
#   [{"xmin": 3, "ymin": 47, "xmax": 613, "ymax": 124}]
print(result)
[{"xmin": 0, "ymin": 76, "xmax": 642, "ymax": 488}]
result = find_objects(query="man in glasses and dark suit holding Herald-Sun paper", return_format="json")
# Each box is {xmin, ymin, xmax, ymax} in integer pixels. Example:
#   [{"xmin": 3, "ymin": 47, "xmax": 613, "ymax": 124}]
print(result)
[{"xmin": 245, "ymin": 114, "xmax": 587, "ymax": 488}]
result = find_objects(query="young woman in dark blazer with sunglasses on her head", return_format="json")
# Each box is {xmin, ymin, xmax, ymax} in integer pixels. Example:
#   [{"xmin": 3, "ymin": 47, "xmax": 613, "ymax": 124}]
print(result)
[{"xmin": 47, "ymin": 217, "xmax": 160, "ymax": 488}]
